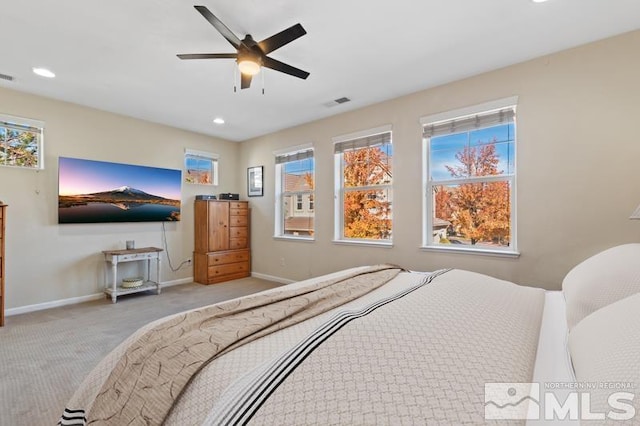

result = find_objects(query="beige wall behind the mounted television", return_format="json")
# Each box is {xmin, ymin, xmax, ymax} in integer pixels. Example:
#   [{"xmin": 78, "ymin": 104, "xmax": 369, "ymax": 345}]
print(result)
[{"xmin": 0, "ymin": 88, "xmax": 241, "ymax": 309}]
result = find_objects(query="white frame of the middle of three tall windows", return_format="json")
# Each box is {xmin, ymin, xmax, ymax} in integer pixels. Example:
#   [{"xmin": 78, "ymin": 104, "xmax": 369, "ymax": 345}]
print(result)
[{"xmin": 332, "ymin": 125, "xmax": 394, "ymax": 248}]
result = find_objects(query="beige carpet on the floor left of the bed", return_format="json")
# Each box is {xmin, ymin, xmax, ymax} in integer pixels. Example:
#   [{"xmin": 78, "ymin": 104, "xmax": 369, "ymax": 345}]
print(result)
[{"xmin": 0, "ymin": 278, "xmax": 280, "ymax": 426}]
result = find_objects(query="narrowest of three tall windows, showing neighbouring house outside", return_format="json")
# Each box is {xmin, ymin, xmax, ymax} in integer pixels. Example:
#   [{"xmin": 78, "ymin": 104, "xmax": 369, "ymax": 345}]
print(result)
[{"xmin": 275, "ymin": 145, "xmax": 315, "ymax": 239}]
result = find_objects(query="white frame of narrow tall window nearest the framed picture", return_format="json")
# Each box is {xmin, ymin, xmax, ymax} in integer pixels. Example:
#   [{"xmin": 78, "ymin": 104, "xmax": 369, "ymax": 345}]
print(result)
[{"xmin": 273, "ymin": 143, "xmax": 316, "ymax": 241}]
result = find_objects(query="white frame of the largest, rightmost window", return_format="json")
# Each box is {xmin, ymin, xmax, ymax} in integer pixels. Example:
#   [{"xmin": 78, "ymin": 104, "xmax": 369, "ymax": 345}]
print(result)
[{"xmin": 420, "ymin": 96, "xmax": 520, "ymax": 257}]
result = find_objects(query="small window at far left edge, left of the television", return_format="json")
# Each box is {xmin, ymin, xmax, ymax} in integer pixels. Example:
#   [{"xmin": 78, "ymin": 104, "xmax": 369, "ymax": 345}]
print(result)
[{"xmin": 0, "ymin": 115, "xmax": 44, "ymax": 169}]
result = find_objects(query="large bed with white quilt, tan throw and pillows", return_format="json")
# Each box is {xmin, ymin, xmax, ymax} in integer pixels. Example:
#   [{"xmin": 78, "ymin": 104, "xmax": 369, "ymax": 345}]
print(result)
[{"xmin": 59, "ymin": 244, "xmax": 640, "ymax": 426}]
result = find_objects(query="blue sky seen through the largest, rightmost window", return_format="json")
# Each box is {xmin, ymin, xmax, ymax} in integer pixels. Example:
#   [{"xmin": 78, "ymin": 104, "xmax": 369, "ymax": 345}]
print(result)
[{"xmin": 429, "ymin": 123, "xmax": 515, "ymax": 180}]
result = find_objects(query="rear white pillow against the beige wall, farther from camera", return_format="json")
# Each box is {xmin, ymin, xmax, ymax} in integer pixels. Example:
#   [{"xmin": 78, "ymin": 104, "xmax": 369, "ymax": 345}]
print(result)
[{"xmin": 562, "ymin": 244, "xmax": 640, "ymax": 330}]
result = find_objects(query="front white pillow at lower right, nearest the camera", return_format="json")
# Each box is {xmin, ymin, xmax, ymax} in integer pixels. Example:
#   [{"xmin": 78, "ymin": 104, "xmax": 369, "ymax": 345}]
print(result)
[{"xmin": 569, "ymin": 293, "xmax": 640, "ymax": 425}]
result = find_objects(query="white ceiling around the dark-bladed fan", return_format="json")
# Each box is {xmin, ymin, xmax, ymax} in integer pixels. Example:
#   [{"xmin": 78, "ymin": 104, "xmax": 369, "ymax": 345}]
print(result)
[{"xmin": 0, "ymin": 0, "xmax": 640, "ymax": 141}]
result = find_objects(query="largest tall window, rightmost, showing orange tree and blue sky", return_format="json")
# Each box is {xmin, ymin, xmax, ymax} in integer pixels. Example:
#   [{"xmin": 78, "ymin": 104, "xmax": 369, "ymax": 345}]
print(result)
[{"xmin": 423, "ymin": 101, "xmax": 516, "ymax": 253}]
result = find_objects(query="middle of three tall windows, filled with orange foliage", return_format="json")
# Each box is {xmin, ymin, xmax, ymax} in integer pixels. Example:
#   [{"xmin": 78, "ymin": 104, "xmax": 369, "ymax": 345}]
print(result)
[{"xmin": 334, "ymin": 128, "xmax": 393, "ymax": 244}]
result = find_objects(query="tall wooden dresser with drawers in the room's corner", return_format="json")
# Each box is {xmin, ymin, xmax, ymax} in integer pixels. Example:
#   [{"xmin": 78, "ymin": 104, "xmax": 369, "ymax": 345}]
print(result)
[{"xmin": 193, "ymin": 200, "xmax": 251, "ymax": 284}]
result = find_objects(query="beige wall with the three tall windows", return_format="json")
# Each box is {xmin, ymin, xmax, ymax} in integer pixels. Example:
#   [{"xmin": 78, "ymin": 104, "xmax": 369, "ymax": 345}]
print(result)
[{"xmin": 240, "ymin": 32, "xmax": 640, "ymax": 289}]
